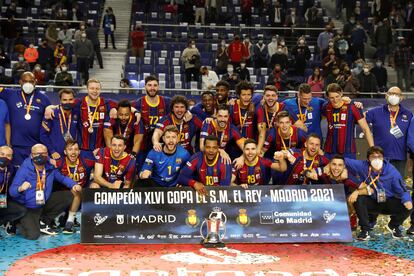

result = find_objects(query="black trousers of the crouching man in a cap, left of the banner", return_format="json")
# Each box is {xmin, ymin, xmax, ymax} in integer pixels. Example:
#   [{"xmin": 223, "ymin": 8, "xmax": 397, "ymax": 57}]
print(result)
[{"xmin": 17, "ymin": 191, "xmax": 73, "ymax": 240}]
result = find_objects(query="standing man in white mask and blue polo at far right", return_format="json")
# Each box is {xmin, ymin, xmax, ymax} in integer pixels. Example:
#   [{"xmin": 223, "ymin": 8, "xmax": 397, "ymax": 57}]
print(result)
[{"xmin": 365, "ymin": 86, "xmax": 413, "ymax": 175}]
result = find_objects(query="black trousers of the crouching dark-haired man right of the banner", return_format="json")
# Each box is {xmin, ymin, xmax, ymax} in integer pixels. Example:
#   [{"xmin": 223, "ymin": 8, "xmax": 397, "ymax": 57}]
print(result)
[{"xmin": 354, "ymin": 196, "xmax": 410, "ymax": 231}]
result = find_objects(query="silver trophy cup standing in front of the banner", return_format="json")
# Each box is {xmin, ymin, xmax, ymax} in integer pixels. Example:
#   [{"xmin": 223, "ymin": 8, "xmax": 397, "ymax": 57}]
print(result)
[{"xmin": 200, "ymin": 207, "xmax": 227, "ymax": 247}]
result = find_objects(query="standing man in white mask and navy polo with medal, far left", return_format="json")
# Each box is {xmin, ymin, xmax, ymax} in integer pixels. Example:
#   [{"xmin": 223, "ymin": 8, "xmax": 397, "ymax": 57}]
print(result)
[{"xmin": 0, "ymin": 72, "xmax": 51, "ymax": 166}]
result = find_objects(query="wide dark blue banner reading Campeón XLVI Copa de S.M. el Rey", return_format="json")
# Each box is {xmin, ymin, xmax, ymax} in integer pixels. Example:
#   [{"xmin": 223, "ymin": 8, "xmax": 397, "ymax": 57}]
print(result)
[{"xmin": 81, "ymin": 184, "xmax": 352, "ymax": 244}]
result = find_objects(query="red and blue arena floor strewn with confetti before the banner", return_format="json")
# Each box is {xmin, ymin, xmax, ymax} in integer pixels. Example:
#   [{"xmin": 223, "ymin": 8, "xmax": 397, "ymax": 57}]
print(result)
[{"xmin": 0, "ymin": 218, "xmax": 414, "ymax": 276}]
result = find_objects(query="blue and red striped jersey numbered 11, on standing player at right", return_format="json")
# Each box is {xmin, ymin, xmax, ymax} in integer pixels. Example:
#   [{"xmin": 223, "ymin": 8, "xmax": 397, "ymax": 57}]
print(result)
[{"xmin": 322, "ymin": 103, "xmax": 364, "ymax": 154}]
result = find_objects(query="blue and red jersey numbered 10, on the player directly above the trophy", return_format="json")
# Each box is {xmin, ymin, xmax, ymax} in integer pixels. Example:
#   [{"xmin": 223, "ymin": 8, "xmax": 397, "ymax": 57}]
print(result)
[{"xmin": 178, "ymin": 152, "xmax": 232, "ymax": 187}]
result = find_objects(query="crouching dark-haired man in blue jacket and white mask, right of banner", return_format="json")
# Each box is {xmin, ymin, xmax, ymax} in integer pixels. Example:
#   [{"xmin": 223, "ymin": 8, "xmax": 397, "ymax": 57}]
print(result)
[{"xmin": 345, "ymin": 146, "xmax": 413, "ymax": 240}]
